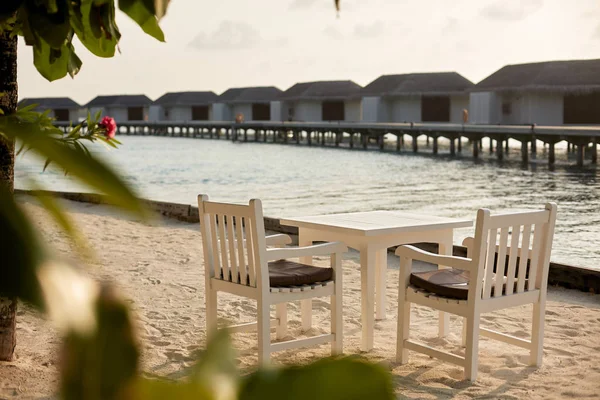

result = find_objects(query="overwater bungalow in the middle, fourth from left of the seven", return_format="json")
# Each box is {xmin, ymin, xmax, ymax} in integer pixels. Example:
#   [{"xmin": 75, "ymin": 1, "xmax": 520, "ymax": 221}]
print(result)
[{"xmin": 213, "ymin": 86, "xmax": 281, "ymax": 121}]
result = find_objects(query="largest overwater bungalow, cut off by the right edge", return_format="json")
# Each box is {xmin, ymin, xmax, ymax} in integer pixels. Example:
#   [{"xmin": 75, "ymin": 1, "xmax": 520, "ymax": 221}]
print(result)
[{"xmin": 470, "ymin": 59, "xmax": 600, "ymax": 125}]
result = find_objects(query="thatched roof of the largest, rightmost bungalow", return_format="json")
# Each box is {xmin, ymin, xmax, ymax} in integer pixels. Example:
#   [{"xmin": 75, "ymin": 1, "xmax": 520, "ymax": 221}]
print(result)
[{"xmin": 473, "ymin": 59, "xmax": 600, "ymax": 93}]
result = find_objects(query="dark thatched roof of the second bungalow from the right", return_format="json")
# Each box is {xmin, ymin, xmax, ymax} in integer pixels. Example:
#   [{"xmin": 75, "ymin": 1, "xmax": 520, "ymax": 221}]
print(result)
[{"xmin": 361, "ymin": 72, "xmax": 473, "ymax": 96}]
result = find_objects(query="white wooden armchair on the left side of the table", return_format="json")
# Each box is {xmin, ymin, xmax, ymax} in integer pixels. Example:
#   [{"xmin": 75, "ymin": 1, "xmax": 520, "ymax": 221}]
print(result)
[{"xmin": 198, "ymin": 195, "xmax": 347, "ymax": 363}]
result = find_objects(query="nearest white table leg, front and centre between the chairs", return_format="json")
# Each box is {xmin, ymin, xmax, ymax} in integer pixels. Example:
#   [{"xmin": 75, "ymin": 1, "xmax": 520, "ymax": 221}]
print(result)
[{"xmin": 360, "ymin": 247, "xmax": 375, "ymax": 351}]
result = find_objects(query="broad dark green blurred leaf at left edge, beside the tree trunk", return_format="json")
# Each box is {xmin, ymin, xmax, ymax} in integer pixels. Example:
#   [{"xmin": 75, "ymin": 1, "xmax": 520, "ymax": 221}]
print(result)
[{"xmin": 0, "ymin": 185, "xmax": 46, "ymax": 307}]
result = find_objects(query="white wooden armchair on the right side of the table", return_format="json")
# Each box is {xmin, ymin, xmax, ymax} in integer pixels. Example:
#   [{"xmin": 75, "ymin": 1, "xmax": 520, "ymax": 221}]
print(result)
[{"xmin": 396, "ymin": 203, "xmax": 556, "ymax": 381}]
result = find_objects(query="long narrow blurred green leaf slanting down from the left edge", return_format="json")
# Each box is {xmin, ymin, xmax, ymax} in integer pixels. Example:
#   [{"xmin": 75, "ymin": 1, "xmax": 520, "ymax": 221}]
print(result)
[{"xmin": 0, "ymin": 113, "xmax": 148, "ymax": 218}]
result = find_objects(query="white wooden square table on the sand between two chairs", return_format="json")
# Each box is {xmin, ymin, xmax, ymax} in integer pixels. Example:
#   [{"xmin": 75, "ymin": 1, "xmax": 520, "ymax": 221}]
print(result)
[{"xmin": 280, "ymin": 211, "xmax": 473, "ymax": 351}]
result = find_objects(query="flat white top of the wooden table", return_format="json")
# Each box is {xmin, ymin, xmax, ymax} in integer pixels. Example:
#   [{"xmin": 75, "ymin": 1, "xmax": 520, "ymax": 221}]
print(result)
[{"xmin": 280, "ymin": 211, "xmax": 473, "ymax": 236}]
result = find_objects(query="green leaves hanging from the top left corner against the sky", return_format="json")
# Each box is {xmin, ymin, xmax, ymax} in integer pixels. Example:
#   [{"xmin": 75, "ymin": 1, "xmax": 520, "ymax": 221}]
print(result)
[{"xmin": 0, "ymin": 0, "xmax": 169, "ymax": 81}]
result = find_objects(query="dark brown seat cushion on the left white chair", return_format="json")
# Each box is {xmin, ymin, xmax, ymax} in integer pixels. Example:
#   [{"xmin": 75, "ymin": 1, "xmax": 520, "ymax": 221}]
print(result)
[{"xmin": 269, "ymin": 260, "xmax": 333, "ymax": 287}]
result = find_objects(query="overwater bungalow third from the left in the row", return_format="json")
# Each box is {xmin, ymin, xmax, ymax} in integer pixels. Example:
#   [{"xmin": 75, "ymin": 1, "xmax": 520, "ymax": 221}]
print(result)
[{"xmin": 150, "ymin": 91, "xmax": 219, "ymax": 122}]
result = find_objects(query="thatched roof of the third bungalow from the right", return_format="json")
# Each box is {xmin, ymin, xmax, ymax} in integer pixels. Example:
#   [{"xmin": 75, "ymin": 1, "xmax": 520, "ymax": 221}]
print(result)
[{"xmin": 279, "ymin": 81, "xmax": 362, "ymax": 100}]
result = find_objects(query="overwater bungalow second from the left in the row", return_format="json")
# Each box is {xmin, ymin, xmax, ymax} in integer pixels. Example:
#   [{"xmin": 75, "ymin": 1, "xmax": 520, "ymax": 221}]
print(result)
[{"xmin": 86, "ymin": 94, "xmax": 152, "ymax": 123}]
